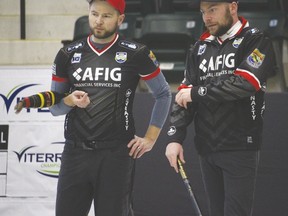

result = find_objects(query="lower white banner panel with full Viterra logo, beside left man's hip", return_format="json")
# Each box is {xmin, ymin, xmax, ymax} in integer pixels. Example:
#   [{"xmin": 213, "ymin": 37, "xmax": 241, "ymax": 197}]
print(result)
[{"xmin": 7, "ymin": 122, "xmax": 64, "ymax": 197}]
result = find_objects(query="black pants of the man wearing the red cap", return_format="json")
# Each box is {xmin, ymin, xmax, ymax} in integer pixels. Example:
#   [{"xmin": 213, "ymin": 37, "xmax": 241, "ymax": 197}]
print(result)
[{"xmin": 56, "ymin": 143, "xmax": 134, "ymax": 216}]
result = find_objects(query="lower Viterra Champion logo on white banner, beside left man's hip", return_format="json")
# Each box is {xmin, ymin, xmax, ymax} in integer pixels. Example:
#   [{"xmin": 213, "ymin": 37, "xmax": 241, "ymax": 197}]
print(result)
[{"xmin": 13, "ymin": 142, "xmax": 64, "ymax": 178}]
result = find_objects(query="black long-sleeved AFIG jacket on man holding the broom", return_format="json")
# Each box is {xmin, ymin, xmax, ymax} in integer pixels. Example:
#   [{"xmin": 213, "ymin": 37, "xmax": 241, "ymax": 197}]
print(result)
[{"xmin": 168, "ymin": 18, "xmax": 277, "ymax": 154}]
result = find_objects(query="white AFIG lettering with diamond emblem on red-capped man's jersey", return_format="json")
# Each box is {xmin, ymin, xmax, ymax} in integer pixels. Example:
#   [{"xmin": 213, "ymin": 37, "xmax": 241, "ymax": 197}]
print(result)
[{"xmin": 73, "ymin": 67, "xmax": 122, "ymax": 82}]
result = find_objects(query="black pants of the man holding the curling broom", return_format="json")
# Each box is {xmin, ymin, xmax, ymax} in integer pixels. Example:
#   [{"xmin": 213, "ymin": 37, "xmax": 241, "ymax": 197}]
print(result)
[{"xmin": 200, "ymin": 151, "xmax": 259, "ymax": 216}]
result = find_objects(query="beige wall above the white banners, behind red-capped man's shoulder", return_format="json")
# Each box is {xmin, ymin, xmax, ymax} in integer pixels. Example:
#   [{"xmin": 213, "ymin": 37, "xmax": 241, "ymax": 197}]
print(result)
[{"xmin": 0, "ymin": 0, "xmax": 88, "ymax": 65}]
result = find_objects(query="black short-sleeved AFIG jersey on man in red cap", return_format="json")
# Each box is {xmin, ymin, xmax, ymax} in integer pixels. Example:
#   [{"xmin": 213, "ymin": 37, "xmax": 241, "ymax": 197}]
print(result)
[{"xmin": 52, "ymin": 35, "xmax": 160, "ymax": 141}]
